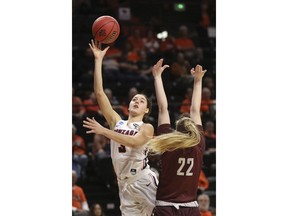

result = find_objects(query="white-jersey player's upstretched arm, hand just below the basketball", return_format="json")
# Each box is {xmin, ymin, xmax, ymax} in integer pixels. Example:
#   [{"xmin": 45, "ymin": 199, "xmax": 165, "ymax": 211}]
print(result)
[{"xmin": 89, "ymin": 40, "xmax": 121, "ymax": 128}]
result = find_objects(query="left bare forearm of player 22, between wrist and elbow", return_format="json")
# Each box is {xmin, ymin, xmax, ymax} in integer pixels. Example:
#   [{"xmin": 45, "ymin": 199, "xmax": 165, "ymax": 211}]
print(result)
[{"xmin": 154, "ymin": 76, "xmax": 168, "ymax": 112}]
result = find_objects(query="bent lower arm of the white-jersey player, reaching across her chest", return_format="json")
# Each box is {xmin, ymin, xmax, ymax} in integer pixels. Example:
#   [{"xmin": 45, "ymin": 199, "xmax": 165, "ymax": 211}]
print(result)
[{"xmin": 83, "ymin": 117, "xmax": 154, "ymax": 147}]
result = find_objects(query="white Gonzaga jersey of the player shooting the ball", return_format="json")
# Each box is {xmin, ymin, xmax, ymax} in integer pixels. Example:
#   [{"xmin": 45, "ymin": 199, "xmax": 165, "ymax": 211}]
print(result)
[{"xmin": 110, "ymin": 120, "xmax": 149, "ymax": 180}]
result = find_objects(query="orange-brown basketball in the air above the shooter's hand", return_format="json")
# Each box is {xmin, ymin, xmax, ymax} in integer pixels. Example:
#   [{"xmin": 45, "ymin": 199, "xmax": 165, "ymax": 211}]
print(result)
[{"xmin": 92, "ymin": 16, "xmax": 120, "ymax": 44}]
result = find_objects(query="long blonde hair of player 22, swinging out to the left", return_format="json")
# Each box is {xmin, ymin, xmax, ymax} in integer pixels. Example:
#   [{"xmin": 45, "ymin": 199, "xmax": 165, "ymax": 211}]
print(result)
[{"xmin": 149, "ymin": 117, "xmax": 200, "ymax": 154}]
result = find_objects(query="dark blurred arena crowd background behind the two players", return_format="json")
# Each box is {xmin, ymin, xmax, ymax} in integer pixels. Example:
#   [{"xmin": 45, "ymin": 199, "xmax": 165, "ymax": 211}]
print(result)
[{"xmin": 72, "ymin": 0, "xmax": 216, "ymax": 216}]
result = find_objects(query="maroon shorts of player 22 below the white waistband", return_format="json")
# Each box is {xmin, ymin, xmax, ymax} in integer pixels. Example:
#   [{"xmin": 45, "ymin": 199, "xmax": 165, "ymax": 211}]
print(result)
[{"xmin": 153, "ymin": 206, "xmax": 200, "ymax": 216}]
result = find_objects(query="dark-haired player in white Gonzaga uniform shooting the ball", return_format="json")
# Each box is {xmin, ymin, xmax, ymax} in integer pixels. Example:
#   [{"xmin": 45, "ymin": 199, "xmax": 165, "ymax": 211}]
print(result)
[{"xmin": 83, "ymin": 40, "xmax": 158, "ymax": 216}]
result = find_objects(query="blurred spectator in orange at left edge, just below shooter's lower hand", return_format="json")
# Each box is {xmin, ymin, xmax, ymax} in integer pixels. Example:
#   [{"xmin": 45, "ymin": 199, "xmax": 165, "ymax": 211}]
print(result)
[{"xmin": 72, "ymin": 125, "xmax": 88, "ymax": 179}]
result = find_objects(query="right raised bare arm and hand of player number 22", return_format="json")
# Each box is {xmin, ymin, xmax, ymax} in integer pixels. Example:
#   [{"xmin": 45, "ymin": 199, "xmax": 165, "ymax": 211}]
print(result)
[{"xmin": 190, "ymin": 65, "xmax": 206, "ymax": 125}]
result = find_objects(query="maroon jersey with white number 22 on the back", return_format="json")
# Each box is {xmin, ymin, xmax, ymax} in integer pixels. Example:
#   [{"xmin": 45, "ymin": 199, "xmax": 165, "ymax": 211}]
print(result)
[{"xmin": 156, "ymin": 124, "xmax": 205, "ymax": 203}]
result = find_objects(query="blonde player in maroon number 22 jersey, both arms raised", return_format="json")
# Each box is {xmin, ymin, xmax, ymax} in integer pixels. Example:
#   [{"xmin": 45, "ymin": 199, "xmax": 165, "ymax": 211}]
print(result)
[{"xmin": 150, "ymin": 59, "xmax": 206, "ymax": 216}]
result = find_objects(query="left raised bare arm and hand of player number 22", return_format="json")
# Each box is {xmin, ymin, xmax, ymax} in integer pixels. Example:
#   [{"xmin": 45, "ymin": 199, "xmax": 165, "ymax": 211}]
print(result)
[{"xmin": 152, "ymin": 59, "xmax": 170, "ymax": 126}]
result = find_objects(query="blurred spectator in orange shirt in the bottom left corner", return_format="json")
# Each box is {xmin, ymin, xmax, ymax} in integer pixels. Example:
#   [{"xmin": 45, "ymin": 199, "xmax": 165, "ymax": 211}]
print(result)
[{"xmin": 72, "ymin": 170, "xmax": 89, "ymax": 216}]
